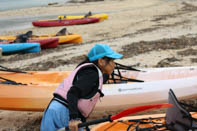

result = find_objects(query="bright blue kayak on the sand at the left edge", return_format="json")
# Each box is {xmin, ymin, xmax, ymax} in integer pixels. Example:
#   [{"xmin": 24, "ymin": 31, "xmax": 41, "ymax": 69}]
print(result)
[{"xmin": 0, "ymin": 43, "xmax": 41, "ymax": 54}]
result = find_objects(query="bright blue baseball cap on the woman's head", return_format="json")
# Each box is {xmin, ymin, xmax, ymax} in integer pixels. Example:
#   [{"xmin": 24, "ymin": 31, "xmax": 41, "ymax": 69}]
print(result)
[{"xmin": 88, "ymin": 44, "xmax": 123, "ymax": 61}]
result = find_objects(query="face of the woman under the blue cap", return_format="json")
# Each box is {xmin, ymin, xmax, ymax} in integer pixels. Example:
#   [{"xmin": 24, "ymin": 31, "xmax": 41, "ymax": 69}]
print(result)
[{"xmin": 98, "ymin": 59, "xmax": 115, "ymax": 75}]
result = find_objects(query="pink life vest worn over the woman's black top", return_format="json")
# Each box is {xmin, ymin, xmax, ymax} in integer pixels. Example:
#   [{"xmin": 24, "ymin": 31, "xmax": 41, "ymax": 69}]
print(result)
[{"xmin": 54, "ymin": 63, "xmax": 103, "ymax": 117}]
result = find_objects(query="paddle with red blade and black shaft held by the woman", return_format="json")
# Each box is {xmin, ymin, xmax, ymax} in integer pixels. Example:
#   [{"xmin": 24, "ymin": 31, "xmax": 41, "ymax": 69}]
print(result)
[{"xmin": 58, "ymin": 104, "xmax": 172, "ymax": 131}]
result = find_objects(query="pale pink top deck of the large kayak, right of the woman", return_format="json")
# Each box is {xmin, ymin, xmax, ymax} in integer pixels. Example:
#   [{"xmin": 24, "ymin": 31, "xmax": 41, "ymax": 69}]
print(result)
[{"xmin": 117, "ymin": 66, "xmax": 197, "ymax": 82}]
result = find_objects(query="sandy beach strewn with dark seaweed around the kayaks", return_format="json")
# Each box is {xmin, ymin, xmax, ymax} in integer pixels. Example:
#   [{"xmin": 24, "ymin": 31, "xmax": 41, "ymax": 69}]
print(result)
[{"xmin": 0, "ymin": 0, "xmax": 197, "ymax": 131}]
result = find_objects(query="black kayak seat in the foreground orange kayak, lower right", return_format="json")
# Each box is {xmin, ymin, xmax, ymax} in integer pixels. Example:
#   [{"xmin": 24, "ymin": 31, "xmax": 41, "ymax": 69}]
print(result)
[{"xmin": 165, "ymin": 89, "xmax": 197, "ymax": 131}]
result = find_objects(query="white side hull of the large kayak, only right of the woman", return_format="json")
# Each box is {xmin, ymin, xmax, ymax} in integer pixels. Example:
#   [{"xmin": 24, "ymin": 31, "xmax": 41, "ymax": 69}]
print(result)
[{"xmin": 95, "ymin": 77, "xmax": 197, "ymax": 111}]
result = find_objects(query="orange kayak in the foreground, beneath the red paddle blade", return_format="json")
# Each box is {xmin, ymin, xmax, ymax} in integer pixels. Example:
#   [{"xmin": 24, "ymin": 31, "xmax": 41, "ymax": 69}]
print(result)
[{"xmin": 91, "ymin": 113, "xmax": 197, "ymax": 131}]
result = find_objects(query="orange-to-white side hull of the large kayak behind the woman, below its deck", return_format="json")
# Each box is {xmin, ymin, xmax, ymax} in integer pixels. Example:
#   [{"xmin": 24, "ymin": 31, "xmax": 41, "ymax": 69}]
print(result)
[{"xmin": 0, "ymin": 77, "xmax": 197, "ymax": 113}]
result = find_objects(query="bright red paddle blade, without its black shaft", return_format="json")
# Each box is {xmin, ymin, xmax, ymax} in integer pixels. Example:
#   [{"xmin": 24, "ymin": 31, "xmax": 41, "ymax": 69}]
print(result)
[{"xmin": 111, "ymin": 104, "xmax": 172, "ymax": 120}]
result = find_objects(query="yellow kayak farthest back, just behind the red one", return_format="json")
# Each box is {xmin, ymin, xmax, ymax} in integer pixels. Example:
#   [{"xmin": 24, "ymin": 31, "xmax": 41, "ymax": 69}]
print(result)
[{"xmin": 58, "ymin": 13, "xmax": 108, "ymax": 21}]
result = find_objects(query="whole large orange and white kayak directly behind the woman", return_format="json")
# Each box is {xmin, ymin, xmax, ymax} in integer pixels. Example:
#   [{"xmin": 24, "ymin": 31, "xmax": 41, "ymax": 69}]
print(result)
[{"xmin": 0, "ymin": 67, "xmax": 197, "ymax": 111}]
